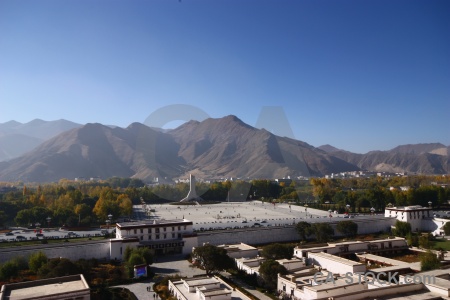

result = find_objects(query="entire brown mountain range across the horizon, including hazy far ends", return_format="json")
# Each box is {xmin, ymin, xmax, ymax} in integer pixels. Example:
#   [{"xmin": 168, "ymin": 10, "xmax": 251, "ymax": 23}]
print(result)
[{"xmin": 0, "ymin": 116, "xmax": 450, "ymax": 182}]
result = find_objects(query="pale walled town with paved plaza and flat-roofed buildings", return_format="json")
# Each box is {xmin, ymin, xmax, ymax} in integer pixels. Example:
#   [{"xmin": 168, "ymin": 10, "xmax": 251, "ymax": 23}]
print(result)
[{"xmin": 0, "ymin": 174, "xmax": 450, "ymax": 300}]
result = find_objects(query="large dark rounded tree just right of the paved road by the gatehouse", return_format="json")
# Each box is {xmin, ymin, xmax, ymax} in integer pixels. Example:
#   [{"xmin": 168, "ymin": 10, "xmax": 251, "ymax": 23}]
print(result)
[{"xmin": 192, "ymin": 244, "xmax": 233, "ymax": 275}]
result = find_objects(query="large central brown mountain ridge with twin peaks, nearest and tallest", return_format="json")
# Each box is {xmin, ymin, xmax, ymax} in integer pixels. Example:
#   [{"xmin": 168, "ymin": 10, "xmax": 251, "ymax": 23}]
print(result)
[{"xmin": 0, "ymin": 116, "xmax": 357, "ymax": 182}]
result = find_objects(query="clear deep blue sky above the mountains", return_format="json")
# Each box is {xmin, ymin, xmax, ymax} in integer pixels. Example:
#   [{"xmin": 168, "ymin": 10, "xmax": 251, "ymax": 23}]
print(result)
[{"xmin": 0, "ymin": 0, "xmax": 450, "ymax": 153}]
